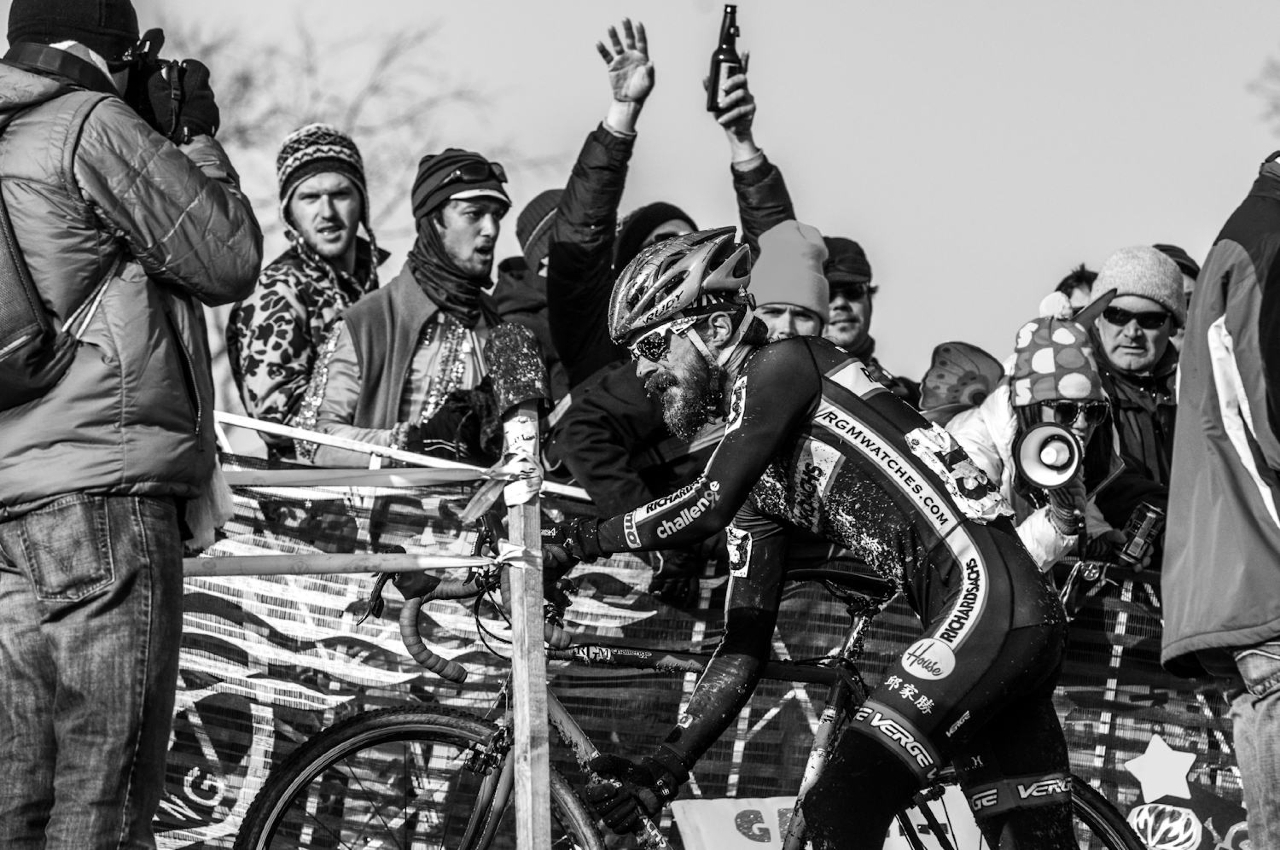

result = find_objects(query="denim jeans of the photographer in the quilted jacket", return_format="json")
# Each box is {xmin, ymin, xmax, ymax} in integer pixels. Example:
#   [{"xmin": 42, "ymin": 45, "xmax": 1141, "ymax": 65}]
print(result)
[{"xmin": 0, "ymin": 494, "xmax": 182, "ymax": 850}]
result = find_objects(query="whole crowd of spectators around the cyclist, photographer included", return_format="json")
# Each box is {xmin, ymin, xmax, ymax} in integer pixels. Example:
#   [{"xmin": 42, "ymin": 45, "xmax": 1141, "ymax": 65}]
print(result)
[{"xmin": 0, "ymin": 0, "xmax": 1280, "ymax": 846}]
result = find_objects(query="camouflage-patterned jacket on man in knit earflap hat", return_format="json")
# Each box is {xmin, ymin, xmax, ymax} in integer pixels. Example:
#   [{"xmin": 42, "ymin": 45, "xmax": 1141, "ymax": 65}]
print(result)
[{"xmin": 227, "ymin": 238, "xmax": 388, "ymax": 454}]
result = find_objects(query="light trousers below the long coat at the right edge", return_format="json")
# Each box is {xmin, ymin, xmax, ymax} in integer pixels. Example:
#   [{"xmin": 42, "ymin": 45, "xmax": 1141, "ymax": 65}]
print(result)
[{"xmin": 1231, "ymin": 640, "xmax": 1280, "ymax": 850}]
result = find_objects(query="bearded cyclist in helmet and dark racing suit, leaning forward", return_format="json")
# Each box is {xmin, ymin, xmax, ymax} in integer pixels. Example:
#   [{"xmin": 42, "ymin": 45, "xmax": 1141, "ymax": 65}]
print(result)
[{"xmin": 543, "ymin": 228, "xmax": 1074, "ymax": 849}]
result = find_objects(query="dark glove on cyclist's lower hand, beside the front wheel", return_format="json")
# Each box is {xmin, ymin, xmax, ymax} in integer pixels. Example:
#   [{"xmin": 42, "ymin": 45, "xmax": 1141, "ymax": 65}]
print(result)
[{"xmin": 584, "ymin": 751, "xmax": 689, "ymax": 835}]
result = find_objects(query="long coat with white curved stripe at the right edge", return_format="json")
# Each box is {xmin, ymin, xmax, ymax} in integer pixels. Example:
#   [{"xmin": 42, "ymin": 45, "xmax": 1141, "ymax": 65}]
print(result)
[{"xmin": 1161, "ymin": 154, "xmax": 1280, "ymax": 675}]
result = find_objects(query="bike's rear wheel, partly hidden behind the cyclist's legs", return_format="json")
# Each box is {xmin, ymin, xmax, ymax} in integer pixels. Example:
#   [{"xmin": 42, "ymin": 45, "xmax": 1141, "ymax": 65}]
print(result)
[{"xmin": 884, "ymin": 776, "xmax": 1147, "ymax": 850}]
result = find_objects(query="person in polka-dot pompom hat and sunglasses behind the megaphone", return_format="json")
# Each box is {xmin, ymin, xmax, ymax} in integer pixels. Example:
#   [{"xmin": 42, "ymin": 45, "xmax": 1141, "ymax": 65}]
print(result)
[{"xmin": 946, "ymin": 305, "xmax": 1123, "ymax": 570}]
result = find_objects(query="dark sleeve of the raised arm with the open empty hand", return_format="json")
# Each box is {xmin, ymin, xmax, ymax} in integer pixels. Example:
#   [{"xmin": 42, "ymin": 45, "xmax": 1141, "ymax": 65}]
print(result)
[{"xmin": 547, "ymin": 124, "xmax": 635, "ymax": 387}]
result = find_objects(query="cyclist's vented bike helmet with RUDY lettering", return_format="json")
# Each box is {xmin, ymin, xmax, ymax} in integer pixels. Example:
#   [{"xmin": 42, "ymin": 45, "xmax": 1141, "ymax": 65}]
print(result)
[{"xmin": 609, "ymin": 228, "xmax": 751, "ymax": 344}]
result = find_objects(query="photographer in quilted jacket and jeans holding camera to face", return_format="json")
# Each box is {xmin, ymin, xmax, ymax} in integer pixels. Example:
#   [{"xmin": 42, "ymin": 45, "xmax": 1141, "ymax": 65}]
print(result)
[{"xmin": 0, "ymin": 0, "xmax": 262, "ymax": 849}]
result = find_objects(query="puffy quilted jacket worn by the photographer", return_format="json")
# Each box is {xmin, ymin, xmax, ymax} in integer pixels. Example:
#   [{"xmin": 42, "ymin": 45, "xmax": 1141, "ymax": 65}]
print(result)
[{"xmin": 0, "ymin": 64, "xmax": 262, "ymax": 518}]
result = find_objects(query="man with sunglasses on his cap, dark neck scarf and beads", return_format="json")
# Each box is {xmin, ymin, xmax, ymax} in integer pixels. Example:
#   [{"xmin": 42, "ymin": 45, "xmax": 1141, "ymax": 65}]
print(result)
[{"xmin": 298, "ymin": 147, "xmax": 545, "ymax": 466}]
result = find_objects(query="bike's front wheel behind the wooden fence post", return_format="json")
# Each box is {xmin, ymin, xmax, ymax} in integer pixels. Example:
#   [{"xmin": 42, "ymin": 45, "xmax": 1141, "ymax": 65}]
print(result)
[{"xmin": 236, "ymin": 707, "xmax": 604, "ymax": 850}]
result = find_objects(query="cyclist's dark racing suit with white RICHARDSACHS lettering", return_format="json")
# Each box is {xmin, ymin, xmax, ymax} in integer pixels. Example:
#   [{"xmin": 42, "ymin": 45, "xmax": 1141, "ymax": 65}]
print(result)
[{"xmin": 588, "ymin": 338, "xmax": 1066, "ymax": 834}]
